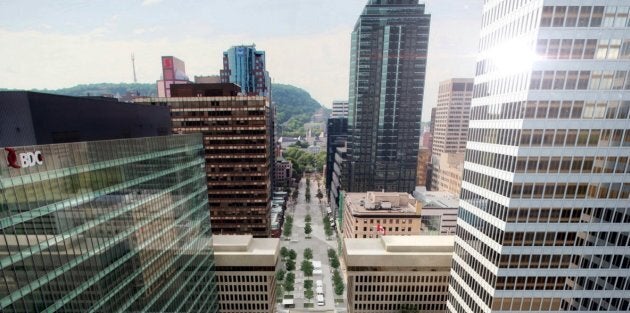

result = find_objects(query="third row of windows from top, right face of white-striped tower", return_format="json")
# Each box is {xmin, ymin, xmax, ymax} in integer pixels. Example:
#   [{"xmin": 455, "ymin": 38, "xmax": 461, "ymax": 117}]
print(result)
[{"xmin": 529, "ymin": 71, "xmax": 630, "ymax": 90}]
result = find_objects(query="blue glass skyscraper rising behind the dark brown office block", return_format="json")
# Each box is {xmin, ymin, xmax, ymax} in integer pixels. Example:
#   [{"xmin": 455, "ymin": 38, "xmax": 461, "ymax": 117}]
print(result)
[{"xmin": 221, "ymin": 45, "xmax": 271, "ymax": 97}]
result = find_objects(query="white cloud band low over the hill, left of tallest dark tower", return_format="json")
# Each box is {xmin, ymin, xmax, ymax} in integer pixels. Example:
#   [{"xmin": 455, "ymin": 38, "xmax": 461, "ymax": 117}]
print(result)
[{"xmin": 0, "ymin": 28, "xmax": 350, "ymax": 106}]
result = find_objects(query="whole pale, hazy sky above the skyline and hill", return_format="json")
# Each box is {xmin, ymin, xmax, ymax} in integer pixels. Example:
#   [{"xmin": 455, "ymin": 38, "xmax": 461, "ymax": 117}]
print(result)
[{"xmin": 0, "ymin": 0, "xmax": 483, "ymax": 121}]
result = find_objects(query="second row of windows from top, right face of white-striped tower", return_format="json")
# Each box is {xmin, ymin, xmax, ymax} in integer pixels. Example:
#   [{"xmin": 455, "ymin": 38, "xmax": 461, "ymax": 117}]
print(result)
[{"xmin": 536, "ymin": 39, "xmax": 630, "ymax": 60}]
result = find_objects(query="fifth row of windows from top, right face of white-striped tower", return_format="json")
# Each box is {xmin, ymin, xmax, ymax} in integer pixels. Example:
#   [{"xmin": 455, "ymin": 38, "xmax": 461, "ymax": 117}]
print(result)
[{"xmin": 520, "ymin": 129, "xmax": 630, "ymax": 148}]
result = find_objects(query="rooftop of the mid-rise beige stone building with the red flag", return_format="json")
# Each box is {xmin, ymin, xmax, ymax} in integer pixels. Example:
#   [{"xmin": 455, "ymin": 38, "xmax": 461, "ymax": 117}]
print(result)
[{"xmin": 345, "ymin": 191, "xmax": 419, "ymax": 215}]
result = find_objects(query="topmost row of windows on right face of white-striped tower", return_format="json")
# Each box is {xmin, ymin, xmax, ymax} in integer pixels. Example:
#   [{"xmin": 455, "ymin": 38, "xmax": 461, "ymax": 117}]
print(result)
[{"xmin": 540, "ymin": 6, "xmax": 630, "ymax": 27}]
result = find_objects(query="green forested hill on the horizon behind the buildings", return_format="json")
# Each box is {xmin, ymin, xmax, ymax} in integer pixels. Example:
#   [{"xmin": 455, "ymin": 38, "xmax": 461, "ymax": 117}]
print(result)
[{"xmin": 0, "ymin": 83, "xmax": 330, "ymax": 135}]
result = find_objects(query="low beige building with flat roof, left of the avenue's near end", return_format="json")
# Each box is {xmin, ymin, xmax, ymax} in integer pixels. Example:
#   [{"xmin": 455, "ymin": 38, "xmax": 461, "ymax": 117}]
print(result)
[{"xmin": 212, "ymin": 235, "xmax": 280, "ymax": 313}]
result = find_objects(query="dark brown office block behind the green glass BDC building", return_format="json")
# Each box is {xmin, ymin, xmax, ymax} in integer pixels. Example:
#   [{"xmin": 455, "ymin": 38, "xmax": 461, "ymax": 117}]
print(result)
[{"xmin": 135, "ymin": 84, "xmax": 273, "ymax": 237}]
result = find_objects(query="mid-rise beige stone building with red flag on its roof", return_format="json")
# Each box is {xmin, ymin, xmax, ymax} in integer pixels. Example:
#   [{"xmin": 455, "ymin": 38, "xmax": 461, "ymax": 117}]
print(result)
[{"xmin": 343, "ymin": 191, "xmax": 421, "ymax": 238}]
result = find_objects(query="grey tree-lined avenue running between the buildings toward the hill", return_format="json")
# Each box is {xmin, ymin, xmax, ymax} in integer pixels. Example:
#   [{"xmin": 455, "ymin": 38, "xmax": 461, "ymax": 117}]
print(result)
[{"xmin": 278, "ymin": 175, "xmax": 346, "ymax": 312}]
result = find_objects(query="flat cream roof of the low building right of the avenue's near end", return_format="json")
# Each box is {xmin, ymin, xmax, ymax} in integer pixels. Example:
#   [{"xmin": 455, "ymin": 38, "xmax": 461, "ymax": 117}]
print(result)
[{"xmin": 344, "ymin": 236, "xmax": 455, "ymax": 267}]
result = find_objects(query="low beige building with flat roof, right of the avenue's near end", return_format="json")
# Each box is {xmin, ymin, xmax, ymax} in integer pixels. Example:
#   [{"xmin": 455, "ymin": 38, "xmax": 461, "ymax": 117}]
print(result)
[{"xmin": 343, "ymin": 236, "xmax": 454, "ymax": 313}]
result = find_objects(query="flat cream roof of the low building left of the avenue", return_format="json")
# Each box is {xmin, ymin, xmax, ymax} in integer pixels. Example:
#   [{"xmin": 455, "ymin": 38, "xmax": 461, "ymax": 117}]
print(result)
[{"xmin": 212, "ymin": 235, "xmax": 280, "ymax": 266}]
